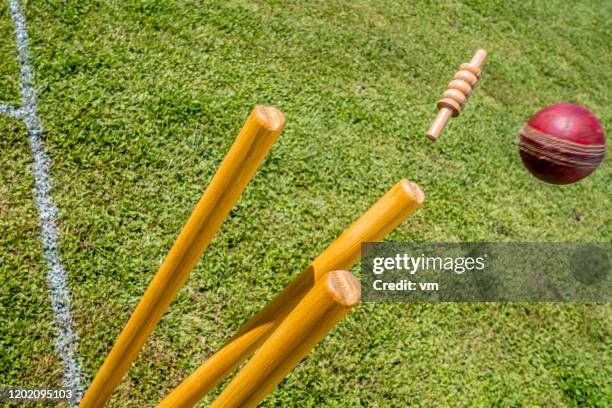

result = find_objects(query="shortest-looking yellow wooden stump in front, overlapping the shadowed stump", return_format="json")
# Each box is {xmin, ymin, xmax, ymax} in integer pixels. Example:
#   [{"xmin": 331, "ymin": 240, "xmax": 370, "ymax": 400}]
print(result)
[{"xmin": 211, "ymin": 271, "xmax": 361, "ymax": 408}]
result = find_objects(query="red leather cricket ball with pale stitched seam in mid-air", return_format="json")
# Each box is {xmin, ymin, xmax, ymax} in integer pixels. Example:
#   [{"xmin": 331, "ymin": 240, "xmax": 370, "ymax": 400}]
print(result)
[{"xmin": 520, "ymin": 103, "xmax": 606, "ymax": 184}]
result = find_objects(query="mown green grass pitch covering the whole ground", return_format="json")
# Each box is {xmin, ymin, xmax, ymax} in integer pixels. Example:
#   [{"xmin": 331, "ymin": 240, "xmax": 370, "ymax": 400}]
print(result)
[{"xmin": 0, "ymin": 1, "xmax": 612, "ymax": 407}]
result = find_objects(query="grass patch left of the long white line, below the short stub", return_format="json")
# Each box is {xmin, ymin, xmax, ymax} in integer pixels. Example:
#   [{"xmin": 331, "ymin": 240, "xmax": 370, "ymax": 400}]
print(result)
[{"xmin": 0, "ymin": 117, "xmax": 61, "ymax": 392}]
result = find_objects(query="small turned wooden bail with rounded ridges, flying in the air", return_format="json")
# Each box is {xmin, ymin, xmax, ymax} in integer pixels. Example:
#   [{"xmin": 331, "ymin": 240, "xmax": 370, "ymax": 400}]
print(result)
[{"xmin": 427, "ymin": 49, "xmax": 487, "ymax": 141}]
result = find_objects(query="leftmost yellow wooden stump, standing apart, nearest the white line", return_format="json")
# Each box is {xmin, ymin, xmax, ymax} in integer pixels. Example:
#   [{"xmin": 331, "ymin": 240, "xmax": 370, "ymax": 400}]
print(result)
[{"xmin": 79, "ymin": 106, "xmax": 285, "ymax": 408}]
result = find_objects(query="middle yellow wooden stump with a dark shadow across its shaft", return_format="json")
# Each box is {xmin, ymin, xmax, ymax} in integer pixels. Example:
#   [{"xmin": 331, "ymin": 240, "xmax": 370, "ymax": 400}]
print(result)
[{"xmin": 158, "ymin": 180, "xmax": 425, "ymax": 408}]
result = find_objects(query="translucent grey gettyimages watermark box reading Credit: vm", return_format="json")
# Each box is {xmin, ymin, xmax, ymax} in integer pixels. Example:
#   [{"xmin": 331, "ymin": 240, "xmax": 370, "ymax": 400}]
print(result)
[{"xmin": 361, "ymin": 243, "xmax": 612, "ymax": 302}]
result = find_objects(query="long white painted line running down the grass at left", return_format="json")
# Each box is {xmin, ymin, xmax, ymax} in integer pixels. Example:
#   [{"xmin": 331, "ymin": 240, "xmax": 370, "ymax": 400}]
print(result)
[{"xmin": 9, "ymin": 0, "xmax": 83, "ymax": 402}]
